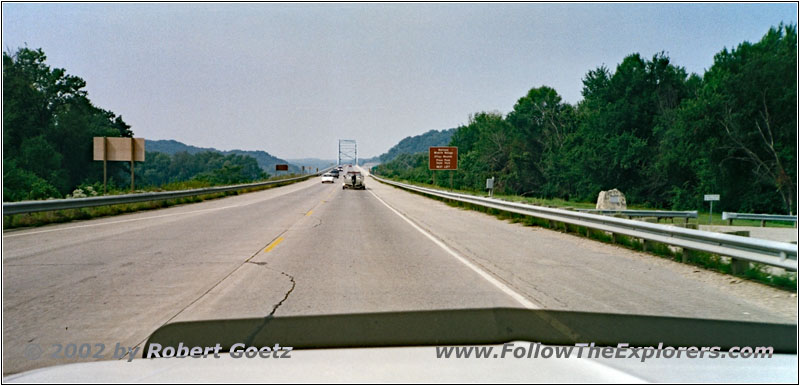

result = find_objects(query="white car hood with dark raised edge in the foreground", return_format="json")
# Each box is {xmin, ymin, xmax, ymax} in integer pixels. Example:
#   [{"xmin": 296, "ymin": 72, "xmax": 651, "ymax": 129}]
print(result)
[{"xmin": 4, "ymin": 308, "xmax": 797, "ymax": 383}]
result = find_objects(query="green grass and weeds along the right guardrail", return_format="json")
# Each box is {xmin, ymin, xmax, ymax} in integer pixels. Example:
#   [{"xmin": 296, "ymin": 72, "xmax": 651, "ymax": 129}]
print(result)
[{"xmin": 378, "ymin": 176, "xmax": 797, "ymax": 292}]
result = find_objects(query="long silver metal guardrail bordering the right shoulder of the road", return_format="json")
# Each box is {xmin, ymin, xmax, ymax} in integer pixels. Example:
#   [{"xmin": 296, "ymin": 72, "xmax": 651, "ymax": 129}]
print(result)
[{"xmin": 372, "ymin": 176, "xmax": 797, "ymax": 271}]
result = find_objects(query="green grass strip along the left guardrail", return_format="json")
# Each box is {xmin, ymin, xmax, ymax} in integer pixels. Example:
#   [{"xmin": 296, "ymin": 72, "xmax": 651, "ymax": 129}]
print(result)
[{"xmin": 3, "ymin": 175, "xmax": 314, "ymax": 230}]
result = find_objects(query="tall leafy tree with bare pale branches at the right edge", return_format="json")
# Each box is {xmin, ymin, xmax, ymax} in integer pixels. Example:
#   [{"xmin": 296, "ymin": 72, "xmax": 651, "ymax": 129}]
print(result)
[{"xmin": 700, "ymin": 25, "xmax": 797, "ymax": 213}]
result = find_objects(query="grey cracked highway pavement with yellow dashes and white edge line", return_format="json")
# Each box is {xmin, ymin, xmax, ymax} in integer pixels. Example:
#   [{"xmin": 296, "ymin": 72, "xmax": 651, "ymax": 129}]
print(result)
[{"xmin": 2, "ymin": 171, "xmax": 797, "ymax": 374}]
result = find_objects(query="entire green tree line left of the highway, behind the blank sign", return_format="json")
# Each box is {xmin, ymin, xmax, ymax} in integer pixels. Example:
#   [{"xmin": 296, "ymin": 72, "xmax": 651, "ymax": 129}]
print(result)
[{"xmin": 3, "ymin": 47, "xmax": 267, "ymax": 201}]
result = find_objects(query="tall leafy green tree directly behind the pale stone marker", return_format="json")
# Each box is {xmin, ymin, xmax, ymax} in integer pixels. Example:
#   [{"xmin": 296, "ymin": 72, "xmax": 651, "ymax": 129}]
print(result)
[{"xmin": 569, "ymin": 53, "xmax": 689, "ymax": 205}]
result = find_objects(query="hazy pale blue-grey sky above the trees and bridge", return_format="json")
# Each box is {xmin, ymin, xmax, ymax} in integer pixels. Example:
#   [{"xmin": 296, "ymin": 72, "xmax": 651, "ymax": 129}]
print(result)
[{"xmin": 2, "ymin": 3, "xmax": 797, "ymax": 159}]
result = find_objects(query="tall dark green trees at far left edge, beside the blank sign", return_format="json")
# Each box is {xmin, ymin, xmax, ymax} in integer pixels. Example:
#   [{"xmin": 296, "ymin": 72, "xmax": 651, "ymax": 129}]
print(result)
[{"xmin": 3, "ymin": 48, "xmax": 133, "ymax": 200}]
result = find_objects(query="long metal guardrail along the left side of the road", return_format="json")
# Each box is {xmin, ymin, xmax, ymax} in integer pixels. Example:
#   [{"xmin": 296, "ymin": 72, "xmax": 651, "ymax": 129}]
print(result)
[{"xmin": 3, "ymin": 167, "xmax": 332, "ymax": 216}]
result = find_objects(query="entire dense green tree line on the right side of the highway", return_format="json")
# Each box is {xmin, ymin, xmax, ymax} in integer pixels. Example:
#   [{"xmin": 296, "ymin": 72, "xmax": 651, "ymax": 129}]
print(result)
[{"xmin": 376, "ymin": 24, "xmax": 797, "ymax": 213}]
